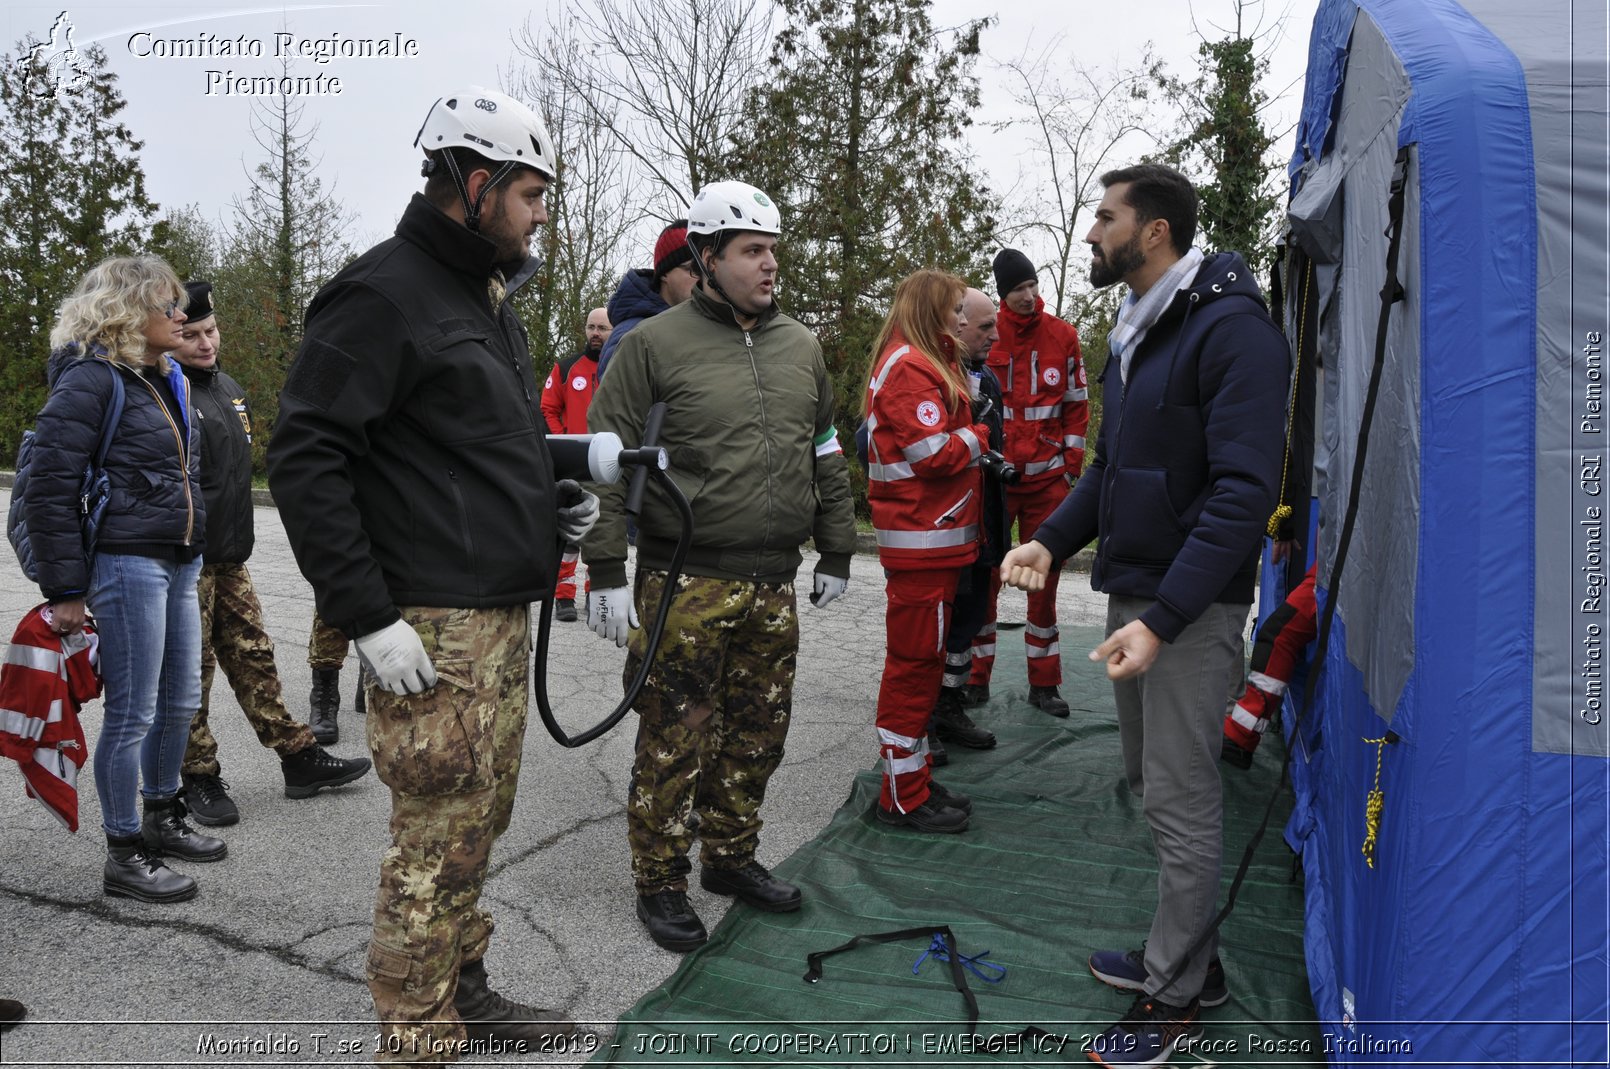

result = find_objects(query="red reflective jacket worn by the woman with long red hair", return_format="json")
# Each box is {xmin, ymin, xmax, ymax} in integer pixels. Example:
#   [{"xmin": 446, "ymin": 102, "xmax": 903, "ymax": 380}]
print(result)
[{"xmin": 866, "ymin": 332, "xmax": 989, "ymax": 570}]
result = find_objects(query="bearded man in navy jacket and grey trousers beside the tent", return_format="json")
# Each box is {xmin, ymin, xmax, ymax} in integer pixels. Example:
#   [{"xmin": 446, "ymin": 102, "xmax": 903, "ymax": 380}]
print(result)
[{"xmin": 1001, "ymin": 164, "xmax": 1291, "ymax": 1066}]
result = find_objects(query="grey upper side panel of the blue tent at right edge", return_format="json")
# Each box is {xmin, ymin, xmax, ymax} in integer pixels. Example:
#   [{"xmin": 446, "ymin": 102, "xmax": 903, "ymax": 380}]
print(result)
[{"xmin": 1465, "ymin": 0, "xmax": 1610, "ymax": 757}]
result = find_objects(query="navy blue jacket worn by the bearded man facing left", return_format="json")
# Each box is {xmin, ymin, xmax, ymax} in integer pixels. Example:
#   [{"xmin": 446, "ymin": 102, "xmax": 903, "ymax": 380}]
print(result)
[{"xmin": 1035, "ymin": 253, "xmax": 1291, "ymax": 642}]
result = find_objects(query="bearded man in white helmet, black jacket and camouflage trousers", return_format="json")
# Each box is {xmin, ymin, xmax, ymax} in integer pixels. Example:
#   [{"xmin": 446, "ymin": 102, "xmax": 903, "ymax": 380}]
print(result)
[{"xmin": 269, "ymin": 87, "xmax": 597, "ymax": 1063}]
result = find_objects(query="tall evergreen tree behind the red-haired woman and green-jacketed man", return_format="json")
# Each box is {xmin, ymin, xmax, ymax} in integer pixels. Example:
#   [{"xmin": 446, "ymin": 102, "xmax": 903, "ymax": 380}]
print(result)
[{"xmin": 731, "ymin": 0, "xmax": 993, "ymax": 467}]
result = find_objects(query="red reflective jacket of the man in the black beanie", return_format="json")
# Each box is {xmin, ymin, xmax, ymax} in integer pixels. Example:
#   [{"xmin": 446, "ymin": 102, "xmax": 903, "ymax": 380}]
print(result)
[{"xmin": 989, "ymin": 298, "xmax": 1090, "ymax": 489}]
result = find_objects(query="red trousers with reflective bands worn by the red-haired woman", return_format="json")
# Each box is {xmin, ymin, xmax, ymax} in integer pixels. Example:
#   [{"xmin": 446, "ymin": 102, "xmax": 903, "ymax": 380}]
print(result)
[{"xmin": 877, "ymin": 568, "xmax": 961, "ymax": 813}]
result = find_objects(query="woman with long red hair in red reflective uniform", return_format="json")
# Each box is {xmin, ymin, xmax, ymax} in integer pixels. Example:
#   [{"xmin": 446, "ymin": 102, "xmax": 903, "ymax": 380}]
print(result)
[{"xmin": 865, "ymin": 270, "xmax": 989, "ymax": 832}]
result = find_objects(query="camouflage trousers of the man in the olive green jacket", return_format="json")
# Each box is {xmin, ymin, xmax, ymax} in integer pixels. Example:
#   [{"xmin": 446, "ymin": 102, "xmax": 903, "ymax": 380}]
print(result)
[{"xmin": 625, "ymin": 568, "xmax": 800, "ymax": 894}]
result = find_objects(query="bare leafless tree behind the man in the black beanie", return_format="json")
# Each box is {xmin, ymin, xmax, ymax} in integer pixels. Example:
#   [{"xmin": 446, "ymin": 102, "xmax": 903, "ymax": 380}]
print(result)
[{"xmin": 997, "ymin": 37, "xmax": 1166, "ymax": 319}]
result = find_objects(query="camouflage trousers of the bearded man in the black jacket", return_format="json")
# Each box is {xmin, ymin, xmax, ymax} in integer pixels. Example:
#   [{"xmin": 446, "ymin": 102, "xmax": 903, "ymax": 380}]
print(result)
[{"xmin": 367, "ymin": 605, "xmax": 531, "ymax": 1063}]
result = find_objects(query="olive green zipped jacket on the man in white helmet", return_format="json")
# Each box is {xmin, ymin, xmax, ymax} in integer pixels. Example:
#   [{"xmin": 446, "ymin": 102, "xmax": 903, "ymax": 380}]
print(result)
[{"xmin": 583, "ymin": 288, "xmax": 855, "ymax": 589}]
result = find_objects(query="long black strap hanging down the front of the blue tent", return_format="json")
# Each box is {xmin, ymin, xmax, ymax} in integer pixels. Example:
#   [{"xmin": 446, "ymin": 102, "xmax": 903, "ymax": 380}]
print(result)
[{"xmin": 1158, "ymin": 145, "xmax": 1410, "ymax": 1001}]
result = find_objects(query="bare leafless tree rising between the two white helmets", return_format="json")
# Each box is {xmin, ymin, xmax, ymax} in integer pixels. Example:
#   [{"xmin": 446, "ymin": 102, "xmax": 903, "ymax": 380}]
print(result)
[{"xmin": 515, "ymin": 0, "xmax": 771, "ymax": 219}]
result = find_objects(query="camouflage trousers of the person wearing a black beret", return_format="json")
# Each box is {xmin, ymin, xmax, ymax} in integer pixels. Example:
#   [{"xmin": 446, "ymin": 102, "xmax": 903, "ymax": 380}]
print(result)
[{"xmin": 184, "ymin": 563, "xmax": 314, "ymax": 776}]
